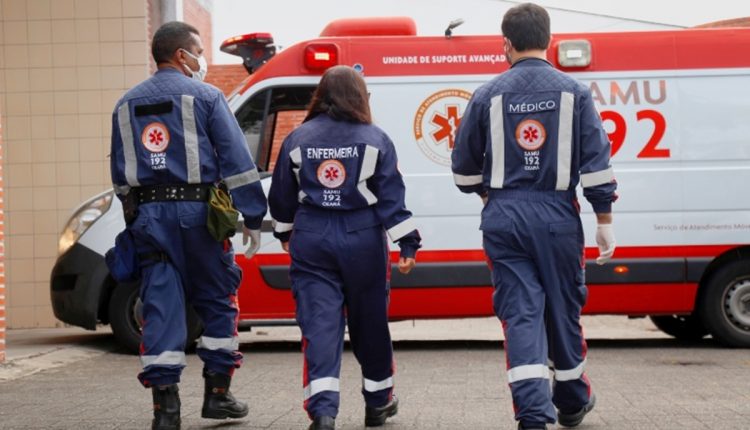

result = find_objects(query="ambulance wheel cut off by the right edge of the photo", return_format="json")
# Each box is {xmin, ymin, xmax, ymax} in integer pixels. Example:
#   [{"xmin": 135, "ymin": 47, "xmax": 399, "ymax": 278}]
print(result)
[{"xmin": 698, "ymin": 260, "xmax": 750, "ymax": 348}]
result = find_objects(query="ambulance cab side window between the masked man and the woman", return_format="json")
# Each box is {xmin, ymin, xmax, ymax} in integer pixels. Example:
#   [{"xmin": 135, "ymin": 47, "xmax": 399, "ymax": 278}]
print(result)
[{"xmin": 237, "ymin": 86, "xmax": 315, "ymax": 176}]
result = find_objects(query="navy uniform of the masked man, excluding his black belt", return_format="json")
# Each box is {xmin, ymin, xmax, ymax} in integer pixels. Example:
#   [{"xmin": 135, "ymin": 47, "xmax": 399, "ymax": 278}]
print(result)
[{"xmin": 111, "ymin": 69, "xmax": 266, "ymax": 387}]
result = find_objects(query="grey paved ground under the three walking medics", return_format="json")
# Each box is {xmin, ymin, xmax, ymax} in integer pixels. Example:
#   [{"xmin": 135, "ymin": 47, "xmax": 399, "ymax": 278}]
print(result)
[{"xmin": 0, "ymin": 316, "xmax": 750, "ymax": 430}]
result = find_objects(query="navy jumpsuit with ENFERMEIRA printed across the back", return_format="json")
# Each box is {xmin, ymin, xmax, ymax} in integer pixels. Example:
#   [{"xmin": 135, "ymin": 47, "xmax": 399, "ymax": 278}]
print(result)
[{"xmin": 268, "ymin": 114, "xmax": 420, "ymax": 417}]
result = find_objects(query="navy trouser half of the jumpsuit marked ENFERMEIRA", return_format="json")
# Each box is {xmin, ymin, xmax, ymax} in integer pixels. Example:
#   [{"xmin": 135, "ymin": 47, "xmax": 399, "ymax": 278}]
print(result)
[{"xmin": 290, "ymin": 207, "xmax": 393, "ymax": 417}]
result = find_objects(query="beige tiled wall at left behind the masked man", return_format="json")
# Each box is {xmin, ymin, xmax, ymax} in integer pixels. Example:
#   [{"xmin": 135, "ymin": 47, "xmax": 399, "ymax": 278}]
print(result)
[{"xmin": 0, "ymin": 0, "xmax": 149, "ymax": 328}]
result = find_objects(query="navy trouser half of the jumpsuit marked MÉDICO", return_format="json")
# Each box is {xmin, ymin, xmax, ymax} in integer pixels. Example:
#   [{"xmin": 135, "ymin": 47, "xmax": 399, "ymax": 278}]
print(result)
[{"xmin": 482, "ymin": 192, "xmax": 590, "ymax": 423}]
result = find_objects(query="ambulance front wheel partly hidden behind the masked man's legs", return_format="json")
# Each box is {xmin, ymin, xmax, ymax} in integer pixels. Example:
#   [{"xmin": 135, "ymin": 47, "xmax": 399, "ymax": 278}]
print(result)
[{"xmin": 109, "ymin": 282, "xmax": 203, "ymax": 354}]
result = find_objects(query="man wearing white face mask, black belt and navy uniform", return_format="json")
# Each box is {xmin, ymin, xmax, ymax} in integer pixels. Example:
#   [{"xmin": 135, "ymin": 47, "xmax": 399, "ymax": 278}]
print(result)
[{"xmin": 111, "ymin": 22, "xmax": 266, "ymax": 429}]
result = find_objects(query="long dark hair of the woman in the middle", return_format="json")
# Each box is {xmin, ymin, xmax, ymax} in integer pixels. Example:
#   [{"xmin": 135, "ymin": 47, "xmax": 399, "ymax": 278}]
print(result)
[{"xmin": 305, "ymin": 66, "xmax": 372, "ymax": 124}]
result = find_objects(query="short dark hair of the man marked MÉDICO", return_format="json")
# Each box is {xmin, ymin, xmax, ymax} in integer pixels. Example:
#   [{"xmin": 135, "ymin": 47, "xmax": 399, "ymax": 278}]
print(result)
[{"xmin": 501, "ymin": 3, "xmax": 550, "ymax": 51}]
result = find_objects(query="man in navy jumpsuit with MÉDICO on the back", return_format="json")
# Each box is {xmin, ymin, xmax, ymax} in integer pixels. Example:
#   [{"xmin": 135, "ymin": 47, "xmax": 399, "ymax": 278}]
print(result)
[{"xmin": 452, "ymin": 3, "xmax": 617, "ymax": 429}]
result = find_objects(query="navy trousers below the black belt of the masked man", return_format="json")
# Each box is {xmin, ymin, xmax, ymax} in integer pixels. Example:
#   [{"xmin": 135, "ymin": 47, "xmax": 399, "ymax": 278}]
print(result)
[{"xmin": 131, "ymin": 202, "xmax": 242, "ymax": 386}]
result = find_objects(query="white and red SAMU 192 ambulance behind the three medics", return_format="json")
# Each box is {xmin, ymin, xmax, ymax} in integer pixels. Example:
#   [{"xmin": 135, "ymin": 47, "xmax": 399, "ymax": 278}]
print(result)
[{"xmin": 51, "ymin": 17, "xmax": 750, "ymax": 350}]
